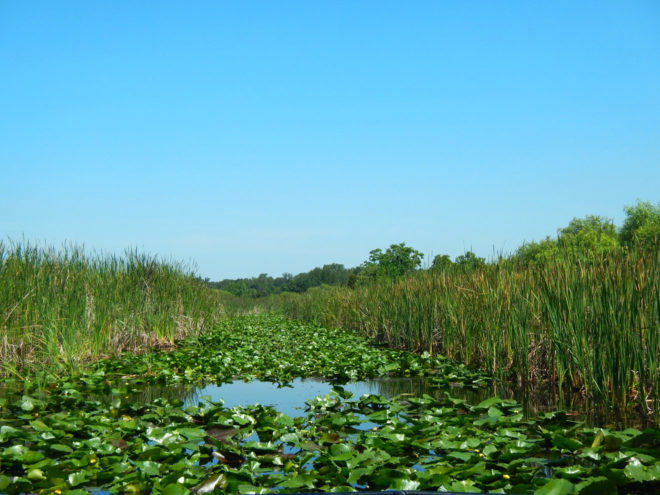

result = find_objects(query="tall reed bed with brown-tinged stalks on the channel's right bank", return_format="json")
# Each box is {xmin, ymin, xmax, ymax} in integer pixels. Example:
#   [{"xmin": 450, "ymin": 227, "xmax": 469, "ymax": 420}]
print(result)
[{"xmin": 265, "ymin": 249, "xmax": 660, "ymax": 408}]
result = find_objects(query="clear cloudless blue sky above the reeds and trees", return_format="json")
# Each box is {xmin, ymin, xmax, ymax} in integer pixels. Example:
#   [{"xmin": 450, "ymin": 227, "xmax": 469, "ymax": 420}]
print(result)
[{"xmin": 0, "ymin": 0, "xmax": 660, "ymax": 280}]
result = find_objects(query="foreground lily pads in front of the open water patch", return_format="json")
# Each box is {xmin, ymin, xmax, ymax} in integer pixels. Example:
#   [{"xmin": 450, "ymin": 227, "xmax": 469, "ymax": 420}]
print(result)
[{"xmin": 0, "ymin": 388, "xmax": 660, "ymax": 494}]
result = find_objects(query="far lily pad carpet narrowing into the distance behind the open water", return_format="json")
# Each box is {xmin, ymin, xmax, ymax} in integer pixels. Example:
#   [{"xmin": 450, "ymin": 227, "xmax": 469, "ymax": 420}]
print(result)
[{"xmin": 83, "ymin": 315, "xmax": 489, "ymax": 388}]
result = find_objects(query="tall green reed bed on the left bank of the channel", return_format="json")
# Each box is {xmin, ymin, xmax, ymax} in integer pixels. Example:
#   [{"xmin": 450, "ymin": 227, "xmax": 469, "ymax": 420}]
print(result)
[{"xmin": 0, "ymin": 243, "xmax": 220, "ymax": 375}]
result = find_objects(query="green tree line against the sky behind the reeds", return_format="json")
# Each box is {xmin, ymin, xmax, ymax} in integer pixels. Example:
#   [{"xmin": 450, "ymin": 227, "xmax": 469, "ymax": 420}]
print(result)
[{"xmin": 205, "ymin": 201, "xmax": 660, "ymax": 297}]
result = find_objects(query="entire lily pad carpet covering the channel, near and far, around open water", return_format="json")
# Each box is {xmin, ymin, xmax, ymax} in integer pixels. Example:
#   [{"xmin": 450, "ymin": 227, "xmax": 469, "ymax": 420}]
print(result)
[{"xmin": 0, "ymin": 316, "xmax": 660, "ymax": 495}]
